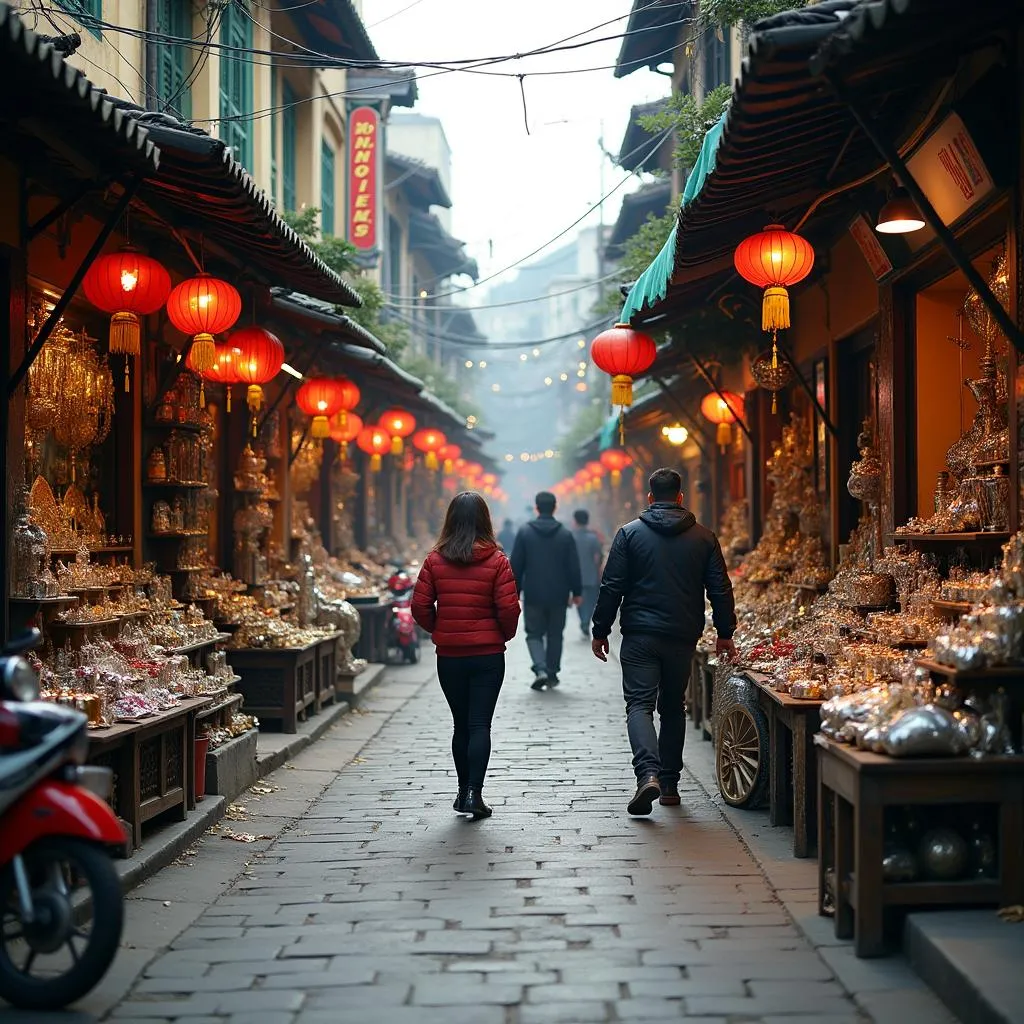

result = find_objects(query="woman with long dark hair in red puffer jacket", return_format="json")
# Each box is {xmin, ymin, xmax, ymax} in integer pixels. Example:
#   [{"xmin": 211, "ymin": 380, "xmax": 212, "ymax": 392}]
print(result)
[{"xmin": 413, "ymin": 490, "xmax": 519, "ymax": 821}]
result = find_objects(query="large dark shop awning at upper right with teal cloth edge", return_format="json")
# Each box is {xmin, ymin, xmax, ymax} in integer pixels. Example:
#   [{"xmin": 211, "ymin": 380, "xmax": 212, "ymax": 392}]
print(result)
[{"xmin": 622, "ymin": 0, "xmax": 1014, "ymax": 325}]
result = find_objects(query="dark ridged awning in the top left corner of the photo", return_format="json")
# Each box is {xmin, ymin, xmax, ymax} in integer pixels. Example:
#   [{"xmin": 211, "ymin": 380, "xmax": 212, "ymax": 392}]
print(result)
[{"xmin": 0, "ymin": 3, "xmax": 160, "ymax": 176}]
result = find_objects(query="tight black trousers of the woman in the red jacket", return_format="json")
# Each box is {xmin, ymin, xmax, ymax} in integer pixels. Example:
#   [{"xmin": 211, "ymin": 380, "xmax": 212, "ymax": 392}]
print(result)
[{"xmin": 437, "ymin": 654, "xmax": 505, "ymax": 790}]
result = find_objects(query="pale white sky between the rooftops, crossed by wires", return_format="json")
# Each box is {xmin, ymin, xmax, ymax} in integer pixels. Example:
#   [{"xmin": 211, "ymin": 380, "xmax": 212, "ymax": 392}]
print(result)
[{"xmin": 362, "ymin": 0, "xmax": 669, "ymax": 296}]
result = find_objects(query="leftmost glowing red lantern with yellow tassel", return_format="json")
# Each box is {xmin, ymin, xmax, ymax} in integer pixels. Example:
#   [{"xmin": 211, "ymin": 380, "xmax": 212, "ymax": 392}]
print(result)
[{"xmin": 82, "ymin": 247, "xmax": 171, "ymax": 355}]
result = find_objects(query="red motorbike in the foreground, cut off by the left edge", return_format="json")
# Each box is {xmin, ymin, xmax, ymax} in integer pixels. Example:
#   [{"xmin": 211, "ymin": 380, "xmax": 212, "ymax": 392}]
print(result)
[{"xmin": 0, "ymin": 630, "xmax": 125, "ymax": 1011}]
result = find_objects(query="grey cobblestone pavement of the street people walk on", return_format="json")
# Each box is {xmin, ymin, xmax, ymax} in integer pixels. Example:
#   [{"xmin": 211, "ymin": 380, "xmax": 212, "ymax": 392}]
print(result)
[{"xmin": 0, "ymin": 627, "xmax": 946, "ymax": 1024}]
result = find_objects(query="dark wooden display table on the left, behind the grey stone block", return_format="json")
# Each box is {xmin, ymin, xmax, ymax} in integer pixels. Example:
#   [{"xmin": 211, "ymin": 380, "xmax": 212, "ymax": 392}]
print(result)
[{"xmin": 228, "ymin": 640, "xmax": 324, "ymax": 732}]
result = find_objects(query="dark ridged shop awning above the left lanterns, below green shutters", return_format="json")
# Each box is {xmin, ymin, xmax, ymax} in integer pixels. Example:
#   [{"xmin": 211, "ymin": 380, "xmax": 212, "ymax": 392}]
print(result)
[{"xmin": 111, "ymin": 99, "xmax": 361, "ymax": 306}]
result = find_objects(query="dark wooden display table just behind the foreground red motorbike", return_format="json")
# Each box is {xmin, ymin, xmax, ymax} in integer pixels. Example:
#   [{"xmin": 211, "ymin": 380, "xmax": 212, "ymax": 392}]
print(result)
[{"xmin": 89, "ymin": 697, "xmax": 211, "ymax": 852}]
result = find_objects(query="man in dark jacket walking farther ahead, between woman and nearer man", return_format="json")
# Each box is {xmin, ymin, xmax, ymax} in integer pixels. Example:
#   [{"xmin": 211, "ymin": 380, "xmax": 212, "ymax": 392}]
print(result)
[{"xmin": 512, "ymin": 490, "xmax": 583, "ymax": 690}]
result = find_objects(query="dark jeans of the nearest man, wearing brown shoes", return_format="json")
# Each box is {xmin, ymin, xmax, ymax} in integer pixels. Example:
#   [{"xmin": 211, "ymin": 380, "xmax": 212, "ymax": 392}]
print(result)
[{"xmin": 618, "ymin": 633, "xmax": 693, "ymax": 788}]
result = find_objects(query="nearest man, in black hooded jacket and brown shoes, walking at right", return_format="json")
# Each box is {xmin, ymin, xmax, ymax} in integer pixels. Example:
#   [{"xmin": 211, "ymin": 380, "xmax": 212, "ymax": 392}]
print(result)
[{"xmin": 592, "ymin": 469, "xmax": 736, "ymax": 814}]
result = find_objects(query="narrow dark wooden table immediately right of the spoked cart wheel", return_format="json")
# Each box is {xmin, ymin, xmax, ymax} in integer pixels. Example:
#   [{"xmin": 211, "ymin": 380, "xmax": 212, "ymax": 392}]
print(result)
[{"xmin": 748, "ymin": 673, "xmax": 822, "ymax": 857}]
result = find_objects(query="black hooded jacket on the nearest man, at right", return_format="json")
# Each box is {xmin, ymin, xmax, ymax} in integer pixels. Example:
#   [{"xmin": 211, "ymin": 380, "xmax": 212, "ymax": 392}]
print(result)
[{"xmin": 594, "ymin": 502, "xmax": 736, "ymax": 645}]
